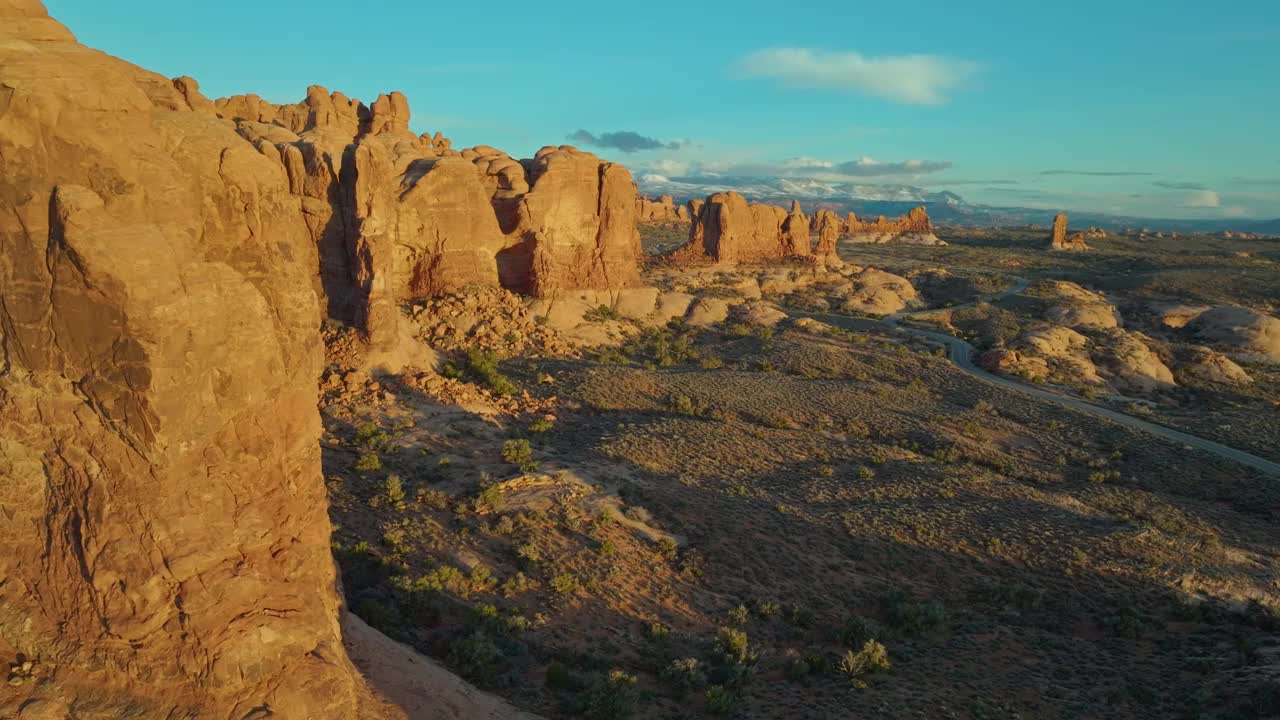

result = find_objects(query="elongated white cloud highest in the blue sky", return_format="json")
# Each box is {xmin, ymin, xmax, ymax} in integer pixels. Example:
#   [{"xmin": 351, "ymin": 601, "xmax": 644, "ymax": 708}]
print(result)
[{"xmin": 739, "ymin": 47, "xmax": 980, "ymax": 105}]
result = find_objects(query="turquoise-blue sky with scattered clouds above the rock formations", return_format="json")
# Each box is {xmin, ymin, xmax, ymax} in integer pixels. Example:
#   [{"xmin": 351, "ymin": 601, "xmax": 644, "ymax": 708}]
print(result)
[{"xmin": 46, "ymin": 0, "xmax": 1280, "ymax": 218}]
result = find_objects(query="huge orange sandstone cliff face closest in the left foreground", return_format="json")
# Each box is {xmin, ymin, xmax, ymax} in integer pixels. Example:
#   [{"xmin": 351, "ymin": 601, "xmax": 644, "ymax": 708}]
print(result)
[{"xmin": 0, "ymin": 0, "xmax": 384, "ymax": 720}]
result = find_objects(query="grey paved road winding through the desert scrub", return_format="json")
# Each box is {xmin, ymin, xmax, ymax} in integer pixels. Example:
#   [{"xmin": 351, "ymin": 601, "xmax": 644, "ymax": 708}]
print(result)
[{"xmin": 801, "ymin": 278, "xmax": 1280, "ymax": 478}]
